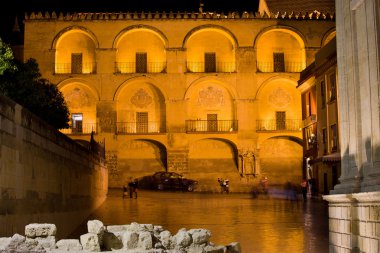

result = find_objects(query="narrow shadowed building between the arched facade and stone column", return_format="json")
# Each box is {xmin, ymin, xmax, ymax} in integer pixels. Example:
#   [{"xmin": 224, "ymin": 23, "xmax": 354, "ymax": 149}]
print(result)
[{"xmin": 297, "ymin": 36, "xmax": 340, "ymax": 195}]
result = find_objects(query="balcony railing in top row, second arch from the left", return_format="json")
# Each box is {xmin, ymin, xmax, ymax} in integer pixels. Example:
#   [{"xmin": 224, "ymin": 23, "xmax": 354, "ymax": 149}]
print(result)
[{"xmin": 115, "ymin": 62, "xmax": 166, "ymax": 74}]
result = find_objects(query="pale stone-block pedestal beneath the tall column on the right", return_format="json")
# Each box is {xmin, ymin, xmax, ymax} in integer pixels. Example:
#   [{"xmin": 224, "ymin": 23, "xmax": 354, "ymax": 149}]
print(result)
[{"xmin": 324, "ymin": 192, "xmax": 380, "ymax": 253}]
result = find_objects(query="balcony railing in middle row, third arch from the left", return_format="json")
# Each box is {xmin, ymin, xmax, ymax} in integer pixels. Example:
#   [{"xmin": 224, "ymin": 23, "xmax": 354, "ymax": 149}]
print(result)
[{"xmin": 186, "ymin": 120, "xmax": 238, "ymax": 133}]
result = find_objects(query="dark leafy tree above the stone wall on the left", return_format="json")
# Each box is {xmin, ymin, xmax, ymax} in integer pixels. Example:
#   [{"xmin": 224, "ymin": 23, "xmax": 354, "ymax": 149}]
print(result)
[{"xmin": 0, "ymin": 39, "xmax": 69, "ymax": 129}]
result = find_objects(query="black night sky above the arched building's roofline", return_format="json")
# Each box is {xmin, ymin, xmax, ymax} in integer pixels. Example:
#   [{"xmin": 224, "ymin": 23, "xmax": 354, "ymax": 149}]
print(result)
[{"xmin": 0, "ymin": 0, "xmax": 259, "ymax": 43}]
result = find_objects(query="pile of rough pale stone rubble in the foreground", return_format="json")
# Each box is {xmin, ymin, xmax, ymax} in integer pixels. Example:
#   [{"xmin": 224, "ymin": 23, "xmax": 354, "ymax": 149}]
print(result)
[{"xmin": 0, "ymin": 220, "xmax": 241, "ymax": 253}]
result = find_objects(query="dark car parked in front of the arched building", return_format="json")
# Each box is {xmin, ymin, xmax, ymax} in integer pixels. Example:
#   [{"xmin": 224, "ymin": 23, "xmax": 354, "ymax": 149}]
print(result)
[{"xmin": 138, "ymin": 171, "xmax": 198, "ymax": 192}]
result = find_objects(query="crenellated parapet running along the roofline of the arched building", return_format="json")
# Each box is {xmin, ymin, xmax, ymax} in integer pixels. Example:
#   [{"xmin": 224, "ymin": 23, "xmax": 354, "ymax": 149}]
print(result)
[{"xmin": 25, "ymin": 11, "xmax": 335, "ymax": 21}]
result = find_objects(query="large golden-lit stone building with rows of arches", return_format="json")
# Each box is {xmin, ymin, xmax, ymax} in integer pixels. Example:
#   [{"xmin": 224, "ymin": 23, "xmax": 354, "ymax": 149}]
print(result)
[{"xmin": 24, "ymin": 1, "xmax": 335, "ymax": 191}]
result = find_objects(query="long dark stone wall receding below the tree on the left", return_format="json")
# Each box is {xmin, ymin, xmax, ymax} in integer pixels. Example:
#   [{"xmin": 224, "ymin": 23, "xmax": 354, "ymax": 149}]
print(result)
[{"xmin": 0, "ymin": 96, "xmax": 108, "ymax": 237}]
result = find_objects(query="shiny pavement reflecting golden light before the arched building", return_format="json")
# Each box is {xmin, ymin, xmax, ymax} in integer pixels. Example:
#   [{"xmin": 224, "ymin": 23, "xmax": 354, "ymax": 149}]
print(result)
[{"xmin": 71, "ymin": 190, "xmax": 328, "ymax": 253}]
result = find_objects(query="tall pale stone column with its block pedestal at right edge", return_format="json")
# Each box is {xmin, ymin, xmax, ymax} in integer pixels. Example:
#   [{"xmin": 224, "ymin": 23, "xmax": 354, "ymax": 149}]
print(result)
[{"xmin": 323, "ymin": 0, "xmax": 380, "ymax": 253}]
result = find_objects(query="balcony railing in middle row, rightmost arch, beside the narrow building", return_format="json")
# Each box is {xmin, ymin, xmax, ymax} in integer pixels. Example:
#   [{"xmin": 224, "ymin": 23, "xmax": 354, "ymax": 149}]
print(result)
[{"xmin": 256, "ymin": 119, "xmax": 302, "ymax": 132}]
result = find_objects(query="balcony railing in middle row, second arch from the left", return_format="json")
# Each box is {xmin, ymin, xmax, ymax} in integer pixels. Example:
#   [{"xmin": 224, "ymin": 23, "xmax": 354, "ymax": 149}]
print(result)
[{"xmin": 116, "ymin": 122, "xmax": 165, "ymax": 134}]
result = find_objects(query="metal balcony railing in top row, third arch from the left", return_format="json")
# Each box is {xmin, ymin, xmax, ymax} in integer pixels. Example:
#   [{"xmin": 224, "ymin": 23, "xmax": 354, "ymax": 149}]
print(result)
[{"xmin": 186, "ymin": 62, "xmax": 236, "ymax": 73}]
